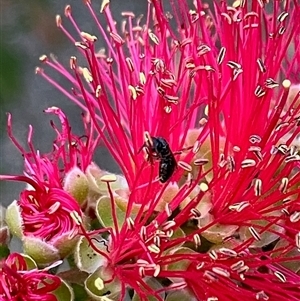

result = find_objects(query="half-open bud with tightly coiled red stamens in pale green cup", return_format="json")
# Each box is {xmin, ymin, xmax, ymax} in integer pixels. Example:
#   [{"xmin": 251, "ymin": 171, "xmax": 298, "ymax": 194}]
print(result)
[{"xmin": 3, "ymin": 176, "xmax": 82, "ymax": 265}]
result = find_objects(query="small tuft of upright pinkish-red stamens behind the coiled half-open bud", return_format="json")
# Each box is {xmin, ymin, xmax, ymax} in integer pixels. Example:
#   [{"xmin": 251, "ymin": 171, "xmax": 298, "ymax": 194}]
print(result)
[{"xmin": 8, "ymin": 107, "xmax": 99, "ymax": 188}]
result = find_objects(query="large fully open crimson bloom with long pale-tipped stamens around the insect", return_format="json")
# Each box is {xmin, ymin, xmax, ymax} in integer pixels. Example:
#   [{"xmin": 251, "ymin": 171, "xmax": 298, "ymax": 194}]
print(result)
[{"xmin": 37, "ymin": 0, "xmax": 300, "ymax": 301}]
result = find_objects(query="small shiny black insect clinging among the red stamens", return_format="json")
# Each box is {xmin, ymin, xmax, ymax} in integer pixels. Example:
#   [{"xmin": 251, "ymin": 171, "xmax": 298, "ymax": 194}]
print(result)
[{"xmin": 142, "ymin": 137, "xmax": 177, "ymax": 183}]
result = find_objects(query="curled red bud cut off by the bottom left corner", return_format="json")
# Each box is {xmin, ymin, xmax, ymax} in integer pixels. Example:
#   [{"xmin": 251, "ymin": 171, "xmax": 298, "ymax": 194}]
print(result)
[{"xmin": 0, "ymin": 253, "xmax": 61, "ymax": 301}]
